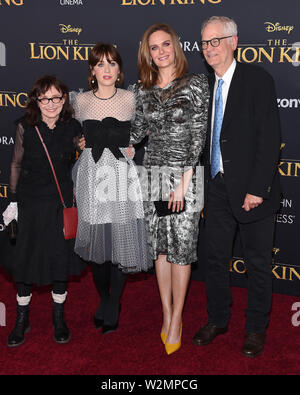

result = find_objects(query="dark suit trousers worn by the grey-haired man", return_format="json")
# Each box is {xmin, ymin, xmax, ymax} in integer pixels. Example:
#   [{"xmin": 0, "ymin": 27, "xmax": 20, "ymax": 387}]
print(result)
[{"xmin": 205, "ymin": 173, "xmax": 275, "ymax": 333}]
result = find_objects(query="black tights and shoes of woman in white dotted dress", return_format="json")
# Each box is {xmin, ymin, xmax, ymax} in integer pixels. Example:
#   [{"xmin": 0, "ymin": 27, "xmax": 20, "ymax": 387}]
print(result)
[{"xmin": 92, "ymin": 262, "xmax": 126, "ymax": 325}]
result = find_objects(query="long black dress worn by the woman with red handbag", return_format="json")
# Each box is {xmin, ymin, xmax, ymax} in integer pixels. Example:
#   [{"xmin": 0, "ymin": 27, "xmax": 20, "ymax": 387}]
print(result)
[{"xmin": 4, "ymin": 119, "xmax": 85, "ymax": 285}]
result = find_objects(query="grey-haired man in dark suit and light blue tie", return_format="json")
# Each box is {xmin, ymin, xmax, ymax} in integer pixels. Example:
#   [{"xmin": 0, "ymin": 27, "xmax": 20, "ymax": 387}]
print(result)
[{"xmin": 193, "ymin": 17, "xmax": 280, "ymax": 357}]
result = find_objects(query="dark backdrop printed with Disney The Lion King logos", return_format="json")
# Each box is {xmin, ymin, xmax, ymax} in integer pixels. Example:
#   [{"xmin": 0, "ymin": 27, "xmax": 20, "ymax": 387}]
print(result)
[{"xmin": 0, "ymin": 0, "xmax": 300, "ymax": 296}]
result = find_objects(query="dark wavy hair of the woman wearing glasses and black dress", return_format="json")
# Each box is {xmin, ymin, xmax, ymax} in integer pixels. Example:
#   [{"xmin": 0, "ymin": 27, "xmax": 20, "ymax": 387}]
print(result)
[{"xmin": 25, "ymin": 75, "xmax": 73, "ymax": 125}]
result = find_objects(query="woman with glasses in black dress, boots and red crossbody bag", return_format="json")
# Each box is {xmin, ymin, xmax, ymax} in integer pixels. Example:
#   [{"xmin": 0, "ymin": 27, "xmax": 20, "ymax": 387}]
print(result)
[{"xmin": 3, "ymin": 76, "xmax": 84, "ymax": 347}]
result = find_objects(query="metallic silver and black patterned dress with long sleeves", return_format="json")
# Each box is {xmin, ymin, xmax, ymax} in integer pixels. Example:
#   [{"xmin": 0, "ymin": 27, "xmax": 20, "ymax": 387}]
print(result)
[{"xmin": 131, "ymin": 74, "xmax": 209, "ymax": 265}]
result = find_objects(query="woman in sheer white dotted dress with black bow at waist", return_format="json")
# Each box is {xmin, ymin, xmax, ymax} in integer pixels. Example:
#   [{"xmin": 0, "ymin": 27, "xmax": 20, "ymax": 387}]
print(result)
[{"xmin": 74, "ymin": 43, "xmax": 152, "ymax": 334}]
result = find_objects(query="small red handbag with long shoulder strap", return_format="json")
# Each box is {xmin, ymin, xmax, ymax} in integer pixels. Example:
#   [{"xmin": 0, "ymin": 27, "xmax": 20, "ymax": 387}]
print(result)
[{"xmin": 35, "ymin": 126, "xmax": 78, "ymax": 240}]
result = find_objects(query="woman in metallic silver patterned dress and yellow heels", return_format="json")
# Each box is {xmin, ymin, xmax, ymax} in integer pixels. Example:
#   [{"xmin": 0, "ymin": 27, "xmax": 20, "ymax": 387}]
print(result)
[{"xmin": 131, "ymin": 24, "xmax": 209, "ymax": 354}]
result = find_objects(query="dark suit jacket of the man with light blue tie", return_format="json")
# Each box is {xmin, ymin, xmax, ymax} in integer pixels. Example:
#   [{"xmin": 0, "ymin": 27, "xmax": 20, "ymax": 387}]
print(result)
[{"xmin": 204, "ymin": 62, "xmax": 281, "ymax": 223}]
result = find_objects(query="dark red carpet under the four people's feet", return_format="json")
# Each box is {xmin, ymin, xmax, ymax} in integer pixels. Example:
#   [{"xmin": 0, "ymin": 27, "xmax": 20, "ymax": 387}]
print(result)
[{"xmin": 0, "ymin": 270, "xmax": 300, "ymax": 375}]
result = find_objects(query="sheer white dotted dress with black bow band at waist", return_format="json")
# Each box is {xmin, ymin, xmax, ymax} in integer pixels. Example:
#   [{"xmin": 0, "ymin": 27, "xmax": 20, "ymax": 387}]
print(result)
[{"xmin": 73, "ymin": 89, "xmax": 153, "ymax": 273}]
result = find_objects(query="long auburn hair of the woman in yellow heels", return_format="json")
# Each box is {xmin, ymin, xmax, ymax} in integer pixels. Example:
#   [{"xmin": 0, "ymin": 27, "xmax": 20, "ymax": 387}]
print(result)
[{"xmin": 138, "ymin": 23, "xmax": 188, "ymax": 88}]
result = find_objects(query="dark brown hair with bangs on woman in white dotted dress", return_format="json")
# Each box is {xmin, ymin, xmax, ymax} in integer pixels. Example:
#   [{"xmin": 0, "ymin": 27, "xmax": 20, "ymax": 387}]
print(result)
[{"xmin": 88, "ymin": 42, "xmax": 124, "ymax": 92}]
